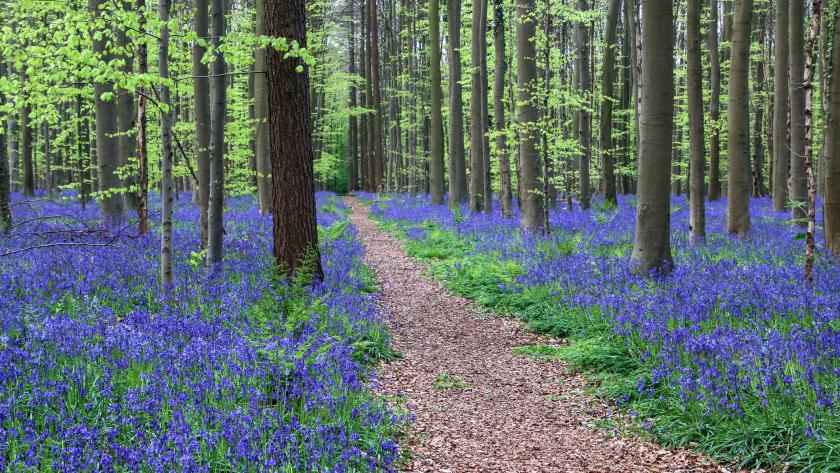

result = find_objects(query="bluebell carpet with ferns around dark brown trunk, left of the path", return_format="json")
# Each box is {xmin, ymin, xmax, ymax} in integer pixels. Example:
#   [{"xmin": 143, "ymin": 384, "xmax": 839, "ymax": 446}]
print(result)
[{"xmin": 0, "ymin": 193, "xmax": 405, "ymax": 472}]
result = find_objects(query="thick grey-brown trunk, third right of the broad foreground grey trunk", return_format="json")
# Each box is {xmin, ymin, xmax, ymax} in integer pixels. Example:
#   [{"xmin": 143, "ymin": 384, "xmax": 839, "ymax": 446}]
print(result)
[{"xmin": 726, "ymin": 0, "xmax": 752, "ymax": 236}]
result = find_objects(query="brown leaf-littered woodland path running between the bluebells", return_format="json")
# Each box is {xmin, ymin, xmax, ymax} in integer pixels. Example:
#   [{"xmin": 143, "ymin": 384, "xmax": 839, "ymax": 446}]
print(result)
[{"xmin": 346, "ymin": 198, "xmax": 725, "ymax": 473}]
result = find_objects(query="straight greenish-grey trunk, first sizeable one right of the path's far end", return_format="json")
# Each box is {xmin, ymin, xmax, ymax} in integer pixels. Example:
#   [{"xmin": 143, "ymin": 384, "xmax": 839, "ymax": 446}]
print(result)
[{"xmin": 429, "ymin": 0, "xmax": 445, "ymax": 205}]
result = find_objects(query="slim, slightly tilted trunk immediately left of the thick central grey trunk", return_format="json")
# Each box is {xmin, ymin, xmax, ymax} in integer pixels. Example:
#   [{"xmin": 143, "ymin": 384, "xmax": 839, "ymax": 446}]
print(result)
[{"xmin": 493, "ymin": 0, "xmax": 513, "ymax": 218}]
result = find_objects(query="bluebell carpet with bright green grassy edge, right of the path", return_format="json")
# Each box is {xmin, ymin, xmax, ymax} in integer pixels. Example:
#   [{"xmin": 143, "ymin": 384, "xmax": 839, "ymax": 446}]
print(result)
[{"xmin": 360, "ymin": 194, "xmax": 840, "ymax": 471}]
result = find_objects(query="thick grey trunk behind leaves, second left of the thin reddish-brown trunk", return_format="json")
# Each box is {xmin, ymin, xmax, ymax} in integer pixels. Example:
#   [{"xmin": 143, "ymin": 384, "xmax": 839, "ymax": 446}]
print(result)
[{"xmin": 88, "ymin": 0, "xmax": 125, "ymax": 224}]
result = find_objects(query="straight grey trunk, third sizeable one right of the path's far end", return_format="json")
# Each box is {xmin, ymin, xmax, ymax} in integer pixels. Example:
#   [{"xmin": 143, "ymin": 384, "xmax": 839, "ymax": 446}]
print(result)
[{"xmin": 470, "ymin": 0, "xmax": 487, "ymax": 212}]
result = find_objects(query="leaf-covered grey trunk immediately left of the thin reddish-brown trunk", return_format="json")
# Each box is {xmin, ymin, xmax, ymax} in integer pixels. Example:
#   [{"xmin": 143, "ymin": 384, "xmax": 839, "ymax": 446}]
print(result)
[{"xmin": 116, "ymin": 0, "xmax": 137, "ymax": 210}]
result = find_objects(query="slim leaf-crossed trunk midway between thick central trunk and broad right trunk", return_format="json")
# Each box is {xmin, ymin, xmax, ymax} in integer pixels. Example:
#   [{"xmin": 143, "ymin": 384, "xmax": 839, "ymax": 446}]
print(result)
[{"xmin": 575, "ymin": 0, "xmax": 592, "ymax": 210}]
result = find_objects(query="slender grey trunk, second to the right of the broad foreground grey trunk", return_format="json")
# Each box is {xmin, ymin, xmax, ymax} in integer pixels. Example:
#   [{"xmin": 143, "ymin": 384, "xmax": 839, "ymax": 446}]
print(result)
[{"xmin": 707, "ymin": 0, "xmax": 721, "ymax": 201}]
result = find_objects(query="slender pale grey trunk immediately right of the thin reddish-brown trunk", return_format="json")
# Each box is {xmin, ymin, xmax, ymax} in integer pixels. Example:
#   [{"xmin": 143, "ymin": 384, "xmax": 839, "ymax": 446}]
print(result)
[{"xmin": 158, "ymin": 0, "xmax": 175, "ymax": 293}]
